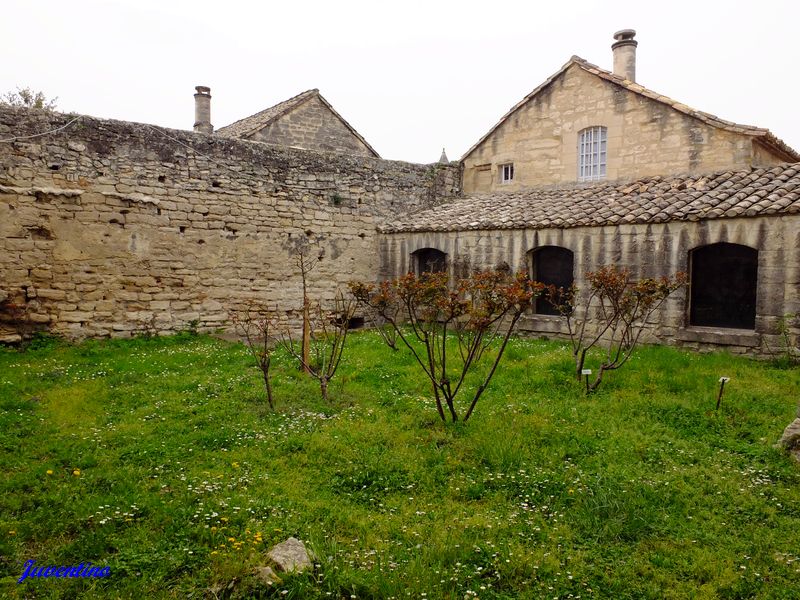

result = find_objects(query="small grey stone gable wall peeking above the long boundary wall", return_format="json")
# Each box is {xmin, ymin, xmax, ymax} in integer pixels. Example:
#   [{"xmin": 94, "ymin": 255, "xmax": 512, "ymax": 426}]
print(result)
[{"xmin": 252, "ymin": 95, "xmax": 373, "ymax": 156}]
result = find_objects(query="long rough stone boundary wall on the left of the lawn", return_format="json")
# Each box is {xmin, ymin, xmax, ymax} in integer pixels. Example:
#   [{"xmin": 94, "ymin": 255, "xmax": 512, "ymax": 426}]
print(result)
[{"xmin": 0, "ymin": 108, "xmax": 460, "ymax": 341}]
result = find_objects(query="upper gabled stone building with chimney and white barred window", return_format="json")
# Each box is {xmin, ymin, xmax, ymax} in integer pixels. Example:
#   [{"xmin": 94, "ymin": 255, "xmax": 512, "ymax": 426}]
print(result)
[{"xmin": 461, "ymin": 29, "xmax": 800, "ymax": 193}]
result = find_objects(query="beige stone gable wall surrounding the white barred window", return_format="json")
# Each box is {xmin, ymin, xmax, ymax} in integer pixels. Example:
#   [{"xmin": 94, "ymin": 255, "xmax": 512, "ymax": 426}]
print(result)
[{"xmin": 464, "ymin": 65, "xmax": 786, "ymax": 193}]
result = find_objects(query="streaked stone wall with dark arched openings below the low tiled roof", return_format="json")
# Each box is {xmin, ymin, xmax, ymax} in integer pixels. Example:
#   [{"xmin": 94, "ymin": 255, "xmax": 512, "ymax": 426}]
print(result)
[{"xmin": 380, "ymin": 215, "xmax": 800, "ymax": 353}]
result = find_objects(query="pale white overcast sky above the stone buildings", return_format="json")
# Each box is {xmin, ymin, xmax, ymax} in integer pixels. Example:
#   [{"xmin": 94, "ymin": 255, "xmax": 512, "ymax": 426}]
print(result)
[{"xmin": 6, "ymin": 0, "xmax": 800, "ymax": 162}]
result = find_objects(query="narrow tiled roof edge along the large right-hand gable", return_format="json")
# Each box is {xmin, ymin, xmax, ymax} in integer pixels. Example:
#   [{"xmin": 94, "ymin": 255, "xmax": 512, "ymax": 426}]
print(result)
[{"xmin": 461, "ymin": 56, "xmax": 800, "ymax": 161}]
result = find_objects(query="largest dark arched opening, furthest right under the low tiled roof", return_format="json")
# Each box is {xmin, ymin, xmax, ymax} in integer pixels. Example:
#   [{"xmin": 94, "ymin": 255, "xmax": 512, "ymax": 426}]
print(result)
[{"xmin": 689, "ymin": 243, "xmax": 758, "ymax": 329}]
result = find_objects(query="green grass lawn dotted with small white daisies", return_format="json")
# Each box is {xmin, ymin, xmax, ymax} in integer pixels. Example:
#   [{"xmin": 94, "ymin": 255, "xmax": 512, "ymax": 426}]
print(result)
[{"xmin": 0, "ymin": 332, "xmax": 800, "ymax": 600}]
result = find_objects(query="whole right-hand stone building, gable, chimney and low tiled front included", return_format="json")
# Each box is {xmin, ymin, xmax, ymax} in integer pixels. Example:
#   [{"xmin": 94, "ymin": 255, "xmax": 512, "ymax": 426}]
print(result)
[{"xmin": 380, "ymin": 30, "xmax": 800, "ymax": 352}]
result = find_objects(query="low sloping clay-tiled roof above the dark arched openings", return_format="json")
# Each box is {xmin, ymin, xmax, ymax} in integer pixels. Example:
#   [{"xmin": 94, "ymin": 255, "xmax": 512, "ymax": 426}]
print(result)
[{"xmin": 381, "ymin": 163, "xmax": 800, "ymax": 232}]
